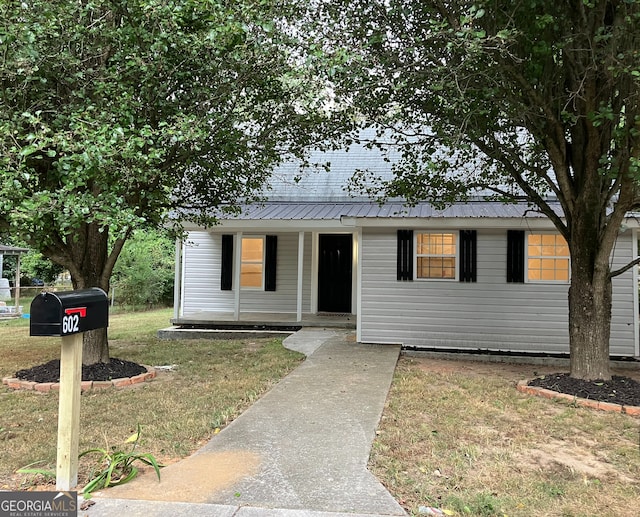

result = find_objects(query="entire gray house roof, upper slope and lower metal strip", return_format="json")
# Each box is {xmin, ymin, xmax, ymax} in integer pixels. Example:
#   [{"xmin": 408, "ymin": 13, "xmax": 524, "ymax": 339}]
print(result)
[{"xmin": 196, "ymin": 129, "xmax": 561, "ymax": 221}]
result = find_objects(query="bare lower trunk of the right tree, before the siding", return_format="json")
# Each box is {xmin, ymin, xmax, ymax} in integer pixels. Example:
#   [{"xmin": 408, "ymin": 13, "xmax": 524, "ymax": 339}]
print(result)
[{"xmin": 569, "ymin": 230, "xmax": 612, "ymax": 380}]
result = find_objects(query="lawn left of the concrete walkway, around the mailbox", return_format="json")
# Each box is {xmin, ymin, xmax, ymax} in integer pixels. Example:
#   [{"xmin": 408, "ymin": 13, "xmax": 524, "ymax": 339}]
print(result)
[{"xmin": 0, "ymin": 309, "xmax": 303, "ymax": 489}]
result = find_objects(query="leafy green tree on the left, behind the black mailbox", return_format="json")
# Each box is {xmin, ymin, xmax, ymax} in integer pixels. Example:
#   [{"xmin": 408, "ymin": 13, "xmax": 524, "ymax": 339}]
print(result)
[{"xmin": 0, "ymin": 0, "xmax": 330, "ymax": 359}]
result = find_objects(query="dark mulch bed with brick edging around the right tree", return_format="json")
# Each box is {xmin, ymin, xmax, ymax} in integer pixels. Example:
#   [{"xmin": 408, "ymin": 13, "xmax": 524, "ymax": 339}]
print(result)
[{"xmin": 529, "ymin": 373, "xmax": 640, "ymax": 406}]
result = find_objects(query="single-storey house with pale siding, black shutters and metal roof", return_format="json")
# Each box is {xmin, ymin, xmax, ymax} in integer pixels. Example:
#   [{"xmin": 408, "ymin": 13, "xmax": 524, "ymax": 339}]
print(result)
[{"xmin": 175, "ymin": 142, "xmax": 640, "ymax": 356}]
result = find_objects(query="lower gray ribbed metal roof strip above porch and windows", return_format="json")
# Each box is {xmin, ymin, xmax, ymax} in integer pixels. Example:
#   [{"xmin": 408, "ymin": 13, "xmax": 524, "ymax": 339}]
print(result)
[{"xmin": 231, "ymin": 201, "xmax": 556, "ymax": 221}]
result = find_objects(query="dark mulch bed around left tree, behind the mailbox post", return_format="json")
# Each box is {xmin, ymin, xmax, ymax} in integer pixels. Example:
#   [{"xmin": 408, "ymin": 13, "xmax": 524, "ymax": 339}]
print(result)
[{"xmin": 15, "ymin": 358, "xmax": 147, "ymax": 382}]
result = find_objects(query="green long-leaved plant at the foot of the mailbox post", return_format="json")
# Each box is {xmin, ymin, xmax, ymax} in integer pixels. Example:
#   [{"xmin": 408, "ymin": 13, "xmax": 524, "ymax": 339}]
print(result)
[{"xmin": 79, "ymin": 424, "xmax": 162, "ymax": 499}]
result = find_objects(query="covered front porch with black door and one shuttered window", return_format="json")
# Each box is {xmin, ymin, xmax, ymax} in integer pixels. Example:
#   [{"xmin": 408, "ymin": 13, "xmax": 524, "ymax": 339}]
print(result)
[{"xmin": 171, "ymin": 220, "xmax": 359, "ymax": 330}]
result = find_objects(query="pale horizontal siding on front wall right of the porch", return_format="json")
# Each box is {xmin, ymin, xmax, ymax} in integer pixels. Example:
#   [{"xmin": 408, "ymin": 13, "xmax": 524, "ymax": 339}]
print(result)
[{"xmin": 360, "ymin": 228, "xmax": 635, "ymax": 355}]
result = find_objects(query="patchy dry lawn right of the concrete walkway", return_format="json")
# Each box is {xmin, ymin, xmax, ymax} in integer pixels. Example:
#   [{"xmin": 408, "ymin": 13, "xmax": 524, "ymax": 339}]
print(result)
[{"xmin": 370, "ymin": 357, "xmax": 640, "ymax": 517}]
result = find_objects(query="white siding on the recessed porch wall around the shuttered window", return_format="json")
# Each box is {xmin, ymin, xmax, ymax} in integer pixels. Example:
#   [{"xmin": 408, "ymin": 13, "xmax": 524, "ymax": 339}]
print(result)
[{"xmin": 182, "ymin": 231, "xmax": 311, "ymax": 316}]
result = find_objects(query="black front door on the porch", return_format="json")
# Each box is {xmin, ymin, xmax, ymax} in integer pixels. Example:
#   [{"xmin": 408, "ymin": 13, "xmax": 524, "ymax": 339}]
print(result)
[{"xmin": 318, "ymin": 234, "xmax": 352, "ymax": 313}]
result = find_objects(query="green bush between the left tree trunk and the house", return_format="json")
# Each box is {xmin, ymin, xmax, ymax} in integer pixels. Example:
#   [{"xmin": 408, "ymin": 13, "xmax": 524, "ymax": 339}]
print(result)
[{"xmin": 112, "ymin": 230, "xmax": 175, "ymax": 307}]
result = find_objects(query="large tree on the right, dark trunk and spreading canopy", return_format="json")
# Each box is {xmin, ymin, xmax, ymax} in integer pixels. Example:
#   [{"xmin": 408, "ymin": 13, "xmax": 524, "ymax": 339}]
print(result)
[{"xmin": 308, "ymin": 0, "xmax": 640, "ymax": 378}]
